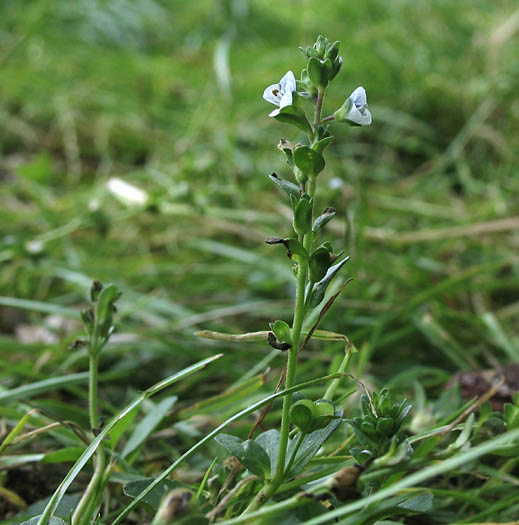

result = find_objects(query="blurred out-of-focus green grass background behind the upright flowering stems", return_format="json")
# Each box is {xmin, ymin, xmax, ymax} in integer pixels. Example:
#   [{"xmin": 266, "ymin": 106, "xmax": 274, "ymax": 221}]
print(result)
[{"xmin": 0, "ymin": 0, "xmax": 519, "ymax": 402}]
